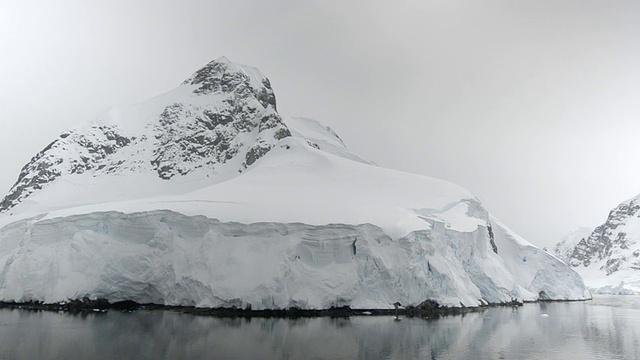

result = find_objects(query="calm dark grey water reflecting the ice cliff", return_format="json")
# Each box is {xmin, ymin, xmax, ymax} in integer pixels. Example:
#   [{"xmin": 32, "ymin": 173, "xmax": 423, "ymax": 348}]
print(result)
[{"xmin": 0, "ymin": 296, "xmax": 640, "ymax": 359}]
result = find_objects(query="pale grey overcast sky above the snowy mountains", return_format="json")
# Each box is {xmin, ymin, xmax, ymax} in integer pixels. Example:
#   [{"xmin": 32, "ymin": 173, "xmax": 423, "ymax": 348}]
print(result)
[{"xmin": 0, "ymin": 0, "xmax": 640, "ymax": 246}]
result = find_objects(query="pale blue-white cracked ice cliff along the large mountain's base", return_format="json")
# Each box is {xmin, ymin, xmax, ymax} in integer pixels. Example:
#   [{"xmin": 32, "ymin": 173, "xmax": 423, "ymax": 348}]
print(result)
[{"xmin": 0, "ymin": 210, "xmax": 589, "ymax": 309}]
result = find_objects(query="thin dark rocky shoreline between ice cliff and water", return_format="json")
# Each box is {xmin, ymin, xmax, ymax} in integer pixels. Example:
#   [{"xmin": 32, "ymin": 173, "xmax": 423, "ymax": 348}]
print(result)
[{"xmin": 0, "ymin": 298, "xmax": 523, "ymax": 318}]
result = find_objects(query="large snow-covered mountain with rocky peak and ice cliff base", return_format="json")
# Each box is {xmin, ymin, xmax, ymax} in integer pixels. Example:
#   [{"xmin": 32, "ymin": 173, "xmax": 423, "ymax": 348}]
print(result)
[{"xmin": 0, "ymin": 58, "xmax": 590, "ymax": 309}]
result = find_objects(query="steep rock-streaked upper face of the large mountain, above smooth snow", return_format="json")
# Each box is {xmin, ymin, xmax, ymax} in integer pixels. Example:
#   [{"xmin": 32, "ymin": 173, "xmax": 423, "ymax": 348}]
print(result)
[{"xmin": 0, "ymin": 58, "xmax": 291, "ymax": 212}]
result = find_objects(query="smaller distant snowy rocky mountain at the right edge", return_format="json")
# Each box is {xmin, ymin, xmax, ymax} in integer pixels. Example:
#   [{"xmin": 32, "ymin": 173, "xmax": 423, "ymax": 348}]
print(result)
[{"xmin": 556, "ymin": 196, "xmax": 640, "ymax": 294}]
